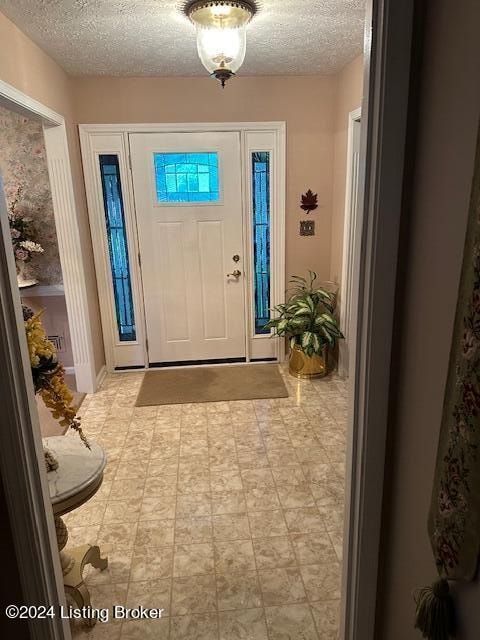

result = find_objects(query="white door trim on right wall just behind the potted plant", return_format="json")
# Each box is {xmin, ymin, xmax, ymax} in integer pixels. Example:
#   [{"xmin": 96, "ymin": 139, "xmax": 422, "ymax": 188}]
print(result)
[{"xmin": 338, "ymin": 107, "xmax": 362, "ymax": 377}]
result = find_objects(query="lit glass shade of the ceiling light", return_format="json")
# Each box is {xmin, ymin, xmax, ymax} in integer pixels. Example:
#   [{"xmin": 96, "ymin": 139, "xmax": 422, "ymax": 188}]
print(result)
[{"xmin": 197, "ymin": 25, "xmax": 247, "ymax": 74}]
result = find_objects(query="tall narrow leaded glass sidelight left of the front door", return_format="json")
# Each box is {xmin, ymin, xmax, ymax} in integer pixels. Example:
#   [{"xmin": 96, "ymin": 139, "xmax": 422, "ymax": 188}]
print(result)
[{"xmin": 99, "ymin": 155, "xmax": 136, "ymax": 342}]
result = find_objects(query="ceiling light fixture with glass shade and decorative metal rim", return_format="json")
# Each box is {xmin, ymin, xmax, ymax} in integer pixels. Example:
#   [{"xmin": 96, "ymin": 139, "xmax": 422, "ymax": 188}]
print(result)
[{"xmin": 185, "ymin": 0, "xmax": 256, "ymax": 87}]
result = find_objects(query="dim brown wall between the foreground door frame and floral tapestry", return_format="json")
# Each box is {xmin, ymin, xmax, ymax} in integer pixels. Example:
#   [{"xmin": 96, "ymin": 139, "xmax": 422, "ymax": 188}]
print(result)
[{"xmin": 376, "ymin": 0, "xmax": 480, "ymax": 640}]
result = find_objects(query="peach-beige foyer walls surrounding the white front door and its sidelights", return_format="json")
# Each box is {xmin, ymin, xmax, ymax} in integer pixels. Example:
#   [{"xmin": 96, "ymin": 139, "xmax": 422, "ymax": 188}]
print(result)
[{"xmin": 0, "ymin": 6, "xmax": 362, "ymax": 369}]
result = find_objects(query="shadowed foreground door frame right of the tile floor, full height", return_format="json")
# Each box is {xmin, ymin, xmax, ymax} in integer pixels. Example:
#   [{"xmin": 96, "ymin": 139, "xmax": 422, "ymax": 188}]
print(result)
[{"xmin": 340, "ymin": 0, "xmax": 420, "ymax": 640}]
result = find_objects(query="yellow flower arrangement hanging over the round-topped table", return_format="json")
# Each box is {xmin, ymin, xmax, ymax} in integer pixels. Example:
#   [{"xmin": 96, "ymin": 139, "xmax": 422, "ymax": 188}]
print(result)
[{"xmin": 23, "ymin": 305, "xmax": 90, "ymax": 471}]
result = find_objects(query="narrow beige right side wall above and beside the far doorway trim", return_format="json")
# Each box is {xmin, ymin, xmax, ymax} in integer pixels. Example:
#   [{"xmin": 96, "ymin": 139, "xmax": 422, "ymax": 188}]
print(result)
[{"xmin": 330, "ymin": 55, "xmax": 363, "ymax": 283}]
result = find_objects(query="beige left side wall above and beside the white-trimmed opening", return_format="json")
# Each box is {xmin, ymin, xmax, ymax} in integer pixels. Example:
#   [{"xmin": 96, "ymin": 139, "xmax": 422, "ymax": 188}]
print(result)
[{"xmin": 0, "ymin": 13, "xmax": 105, "ymax": 371}]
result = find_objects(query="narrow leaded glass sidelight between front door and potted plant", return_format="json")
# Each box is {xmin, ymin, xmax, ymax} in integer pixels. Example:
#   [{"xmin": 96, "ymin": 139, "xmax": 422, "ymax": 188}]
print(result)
[{"xmin": 252, "ymin": 151, "xmax": 270, "ymax": 334}]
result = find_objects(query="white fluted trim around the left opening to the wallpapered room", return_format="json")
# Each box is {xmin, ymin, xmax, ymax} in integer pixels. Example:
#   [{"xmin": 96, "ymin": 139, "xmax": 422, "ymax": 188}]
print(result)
[{"xmin": 0, "ymin": 80, "xmax": 97, "ymax": 393}]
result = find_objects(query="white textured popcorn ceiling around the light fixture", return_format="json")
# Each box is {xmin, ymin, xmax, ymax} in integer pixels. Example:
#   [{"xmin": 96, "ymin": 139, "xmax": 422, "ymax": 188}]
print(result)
[{"xmin": 0, "ymin": 0, "xmax": 364, "ymax": 76}]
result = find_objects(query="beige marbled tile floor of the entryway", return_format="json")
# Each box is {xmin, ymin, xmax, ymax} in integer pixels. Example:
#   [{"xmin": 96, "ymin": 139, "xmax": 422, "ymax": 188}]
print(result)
[{"xmin": 65, "ymin": 367, "xmax": 346, "ymax": 640}]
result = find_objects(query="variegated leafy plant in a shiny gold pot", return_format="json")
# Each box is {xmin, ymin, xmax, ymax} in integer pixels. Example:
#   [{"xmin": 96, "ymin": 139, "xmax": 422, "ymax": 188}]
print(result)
[{"xmin": 265, "ymin": 271, "xmax": 344, "ymax": 378}]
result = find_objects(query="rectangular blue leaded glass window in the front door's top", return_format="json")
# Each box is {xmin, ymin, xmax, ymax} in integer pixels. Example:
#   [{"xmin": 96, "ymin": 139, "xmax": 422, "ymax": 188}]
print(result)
[{"xmin": 154, "ymin": 153, "xmax": 220, "ymax": 203}]
